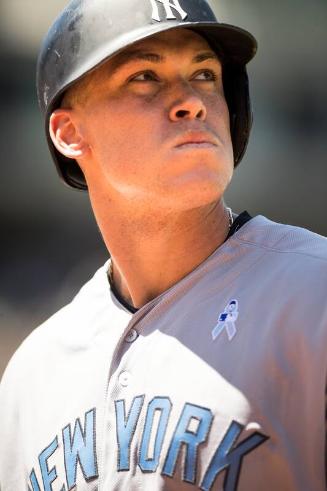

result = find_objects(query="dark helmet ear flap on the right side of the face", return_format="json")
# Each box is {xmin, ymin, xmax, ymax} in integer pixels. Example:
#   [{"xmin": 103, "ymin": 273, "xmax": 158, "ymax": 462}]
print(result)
[{"xmin": 223, "ymin": 62, "xmax": 253, "ymax": 167}]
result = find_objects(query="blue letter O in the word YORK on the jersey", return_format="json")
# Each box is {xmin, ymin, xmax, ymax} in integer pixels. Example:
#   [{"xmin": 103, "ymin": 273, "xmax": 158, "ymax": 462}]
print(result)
[{"xmin": 139, "ymin": 397, "xmax": 172, "ymax": 472}]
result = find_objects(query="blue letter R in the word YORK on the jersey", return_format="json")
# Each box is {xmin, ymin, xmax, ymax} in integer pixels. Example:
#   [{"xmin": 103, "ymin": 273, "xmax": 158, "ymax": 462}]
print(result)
[{"xmin": 162, "ymin": 404, "xmax": 213, "ymax": 484}]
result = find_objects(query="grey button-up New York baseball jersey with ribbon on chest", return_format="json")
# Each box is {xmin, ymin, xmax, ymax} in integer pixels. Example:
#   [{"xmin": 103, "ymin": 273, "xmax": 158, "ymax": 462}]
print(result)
[{"xmin": 0, "ymin": 216, "xmax": 327, "ymax": 491}]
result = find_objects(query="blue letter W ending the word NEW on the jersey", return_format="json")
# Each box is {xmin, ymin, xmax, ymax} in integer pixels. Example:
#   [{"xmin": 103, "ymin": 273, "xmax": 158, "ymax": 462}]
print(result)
[{"xmin": 62, "ymin": 409, "xmax": 98, "ymax": 490}]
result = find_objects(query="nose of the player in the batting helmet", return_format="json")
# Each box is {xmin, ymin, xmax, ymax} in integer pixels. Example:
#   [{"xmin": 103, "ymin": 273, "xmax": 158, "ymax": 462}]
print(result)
[{"xmin": 169, "ymin": 84, "xmax": 207, "ymax": 121}]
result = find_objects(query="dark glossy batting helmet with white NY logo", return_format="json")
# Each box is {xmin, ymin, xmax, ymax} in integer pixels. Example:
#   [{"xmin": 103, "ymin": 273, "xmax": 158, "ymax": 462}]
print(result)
[{"xmin": 37, "ymin": 0, "xmax": 257, "ymax": 190}]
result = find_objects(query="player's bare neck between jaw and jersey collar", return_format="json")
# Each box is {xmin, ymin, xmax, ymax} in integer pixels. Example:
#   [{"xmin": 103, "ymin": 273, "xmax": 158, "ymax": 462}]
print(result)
[{"xmin": 93, "ymin": 200, "xmax": 230, "ymax": 308}]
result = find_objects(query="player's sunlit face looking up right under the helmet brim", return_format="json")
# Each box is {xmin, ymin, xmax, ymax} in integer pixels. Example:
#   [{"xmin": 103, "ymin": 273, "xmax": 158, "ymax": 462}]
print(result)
[{"xmin": 69, "ymin": 29, "xmax": 234, "ymax": 210}]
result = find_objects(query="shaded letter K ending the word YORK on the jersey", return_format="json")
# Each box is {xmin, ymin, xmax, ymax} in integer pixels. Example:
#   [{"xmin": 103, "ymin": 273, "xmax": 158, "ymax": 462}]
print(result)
[{"xmin": 201, "ymin": 421, "xmax": 268, "ymax": 491}]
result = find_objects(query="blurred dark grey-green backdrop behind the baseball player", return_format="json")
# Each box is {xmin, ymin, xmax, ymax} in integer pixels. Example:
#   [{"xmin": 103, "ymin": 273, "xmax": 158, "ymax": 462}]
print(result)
[{"xmin": 0, "ymin": 0, "xmax": 327, "ymax": 376}]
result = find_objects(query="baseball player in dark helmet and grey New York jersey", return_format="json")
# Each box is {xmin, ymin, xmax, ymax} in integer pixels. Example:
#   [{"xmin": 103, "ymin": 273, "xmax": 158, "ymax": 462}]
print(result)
[{"xmin": 0, "ymin": 0, "xmax": 327, "ymax": 491}]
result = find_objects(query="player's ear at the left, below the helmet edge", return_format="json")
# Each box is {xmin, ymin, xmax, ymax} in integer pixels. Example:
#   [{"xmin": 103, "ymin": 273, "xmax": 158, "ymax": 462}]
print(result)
[{"xmin": 49, "ymin": 109, "xmax": 89, "ymax": 160}]
